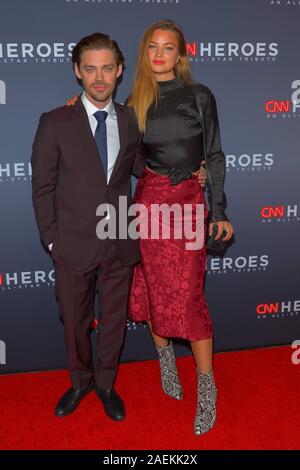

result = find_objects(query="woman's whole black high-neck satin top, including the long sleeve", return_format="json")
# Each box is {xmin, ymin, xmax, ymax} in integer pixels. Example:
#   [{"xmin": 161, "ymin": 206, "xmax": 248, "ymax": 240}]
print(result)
[{"xmin": 127, "ymin": 77, "xmax": 228, "ymax": 220}]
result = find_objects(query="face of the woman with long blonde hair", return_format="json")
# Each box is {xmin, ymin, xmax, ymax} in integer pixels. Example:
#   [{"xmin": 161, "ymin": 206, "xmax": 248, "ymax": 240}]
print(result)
[{"xmin": 148, "ymin": 29, "xmax": 179, "ymax": 81}]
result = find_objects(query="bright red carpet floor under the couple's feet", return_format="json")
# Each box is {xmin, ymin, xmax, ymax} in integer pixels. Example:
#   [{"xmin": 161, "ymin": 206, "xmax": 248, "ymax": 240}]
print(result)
[{"xmin": 0, "ymin": 346, "xmax": 300, "ymax": 450}]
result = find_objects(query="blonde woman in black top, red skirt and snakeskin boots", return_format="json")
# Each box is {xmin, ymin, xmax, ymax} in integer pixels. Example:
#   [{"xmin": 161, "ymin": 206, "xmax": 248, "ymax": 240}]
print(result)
[{"xmin": 128, "ymin": 20, "xmax": 233, "ymax": 434}]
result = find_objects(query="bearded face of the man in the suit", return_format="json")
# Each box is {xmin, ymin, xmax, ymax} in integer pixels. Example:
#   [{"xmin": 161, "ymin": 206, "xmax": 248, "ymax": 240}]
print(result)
[{"xmin": 74, "ymin": 49, "xmax": 122, "ymax": 108}]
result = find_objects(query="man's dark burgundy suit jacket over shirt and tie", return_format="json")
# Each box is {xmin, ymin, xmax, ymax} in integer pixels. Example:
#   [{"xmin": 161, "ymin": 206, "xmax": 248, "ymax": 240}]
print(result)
[{"xmin": 31, "ymin": 100, "xmax": 145, "ymax": 270}]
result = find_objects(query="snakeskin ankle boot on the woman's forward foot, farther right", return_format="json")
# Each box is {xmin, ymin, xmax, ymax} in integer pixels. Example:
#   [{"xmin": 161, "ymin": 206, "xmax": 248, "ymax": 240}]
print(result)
[{"xmin": 194, "ymin": 371, "xmax": 218, "ymax": 435}]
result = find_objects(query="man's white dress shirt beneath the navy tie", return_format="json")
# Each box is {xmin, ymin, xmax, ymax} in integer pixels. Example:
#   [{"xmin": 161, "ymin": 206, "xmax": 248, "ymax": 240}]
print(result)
[{"xmin": 48, "ymin": 91, "xmax": 120, "ymax": 251}]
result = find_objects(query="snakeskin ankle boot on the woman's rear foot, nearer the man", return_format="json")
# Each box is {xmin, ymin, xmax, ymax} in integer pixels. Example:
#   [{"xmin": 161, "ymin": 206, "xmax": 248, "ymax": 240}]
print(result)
[{"xmin": 155, "ymin": 341, "xmax": 183, "ymax": 400}]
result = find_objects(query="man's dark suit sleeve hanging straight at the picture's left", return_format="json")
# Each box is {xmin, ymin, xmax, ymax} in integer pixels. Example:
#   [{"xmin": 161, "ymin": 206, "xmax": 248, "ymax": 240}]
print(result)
[{"xmin": 31, "ymin": 114, "xmax": 60, "ymax": 249}]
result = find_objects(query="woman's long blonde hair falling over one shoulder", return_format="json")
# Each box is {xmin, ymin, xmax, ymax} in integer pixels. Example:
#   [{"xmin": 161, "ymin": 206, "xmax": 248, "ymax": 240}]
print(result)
[{"xmin": 128, "ymin": 20, "xmax": 193, "ymax": 132}]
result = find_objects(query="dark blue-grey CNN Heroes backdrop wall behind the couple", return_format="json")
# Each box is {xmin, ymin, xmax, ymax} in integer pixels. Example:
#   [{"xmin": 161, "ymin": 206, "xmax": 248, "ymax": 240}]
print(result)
[{"xmin": 0, "ymin": 0, "xmax": 300, "ymax": 373}]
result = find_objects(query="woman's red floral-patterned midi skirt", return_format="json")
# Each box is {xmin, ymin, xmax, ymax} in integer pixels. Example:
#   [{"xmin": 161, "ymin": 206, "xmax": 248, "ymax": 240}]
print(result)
[{"xmin": 128, "ymin": 168, "xmax": 213, "ymax": 341}]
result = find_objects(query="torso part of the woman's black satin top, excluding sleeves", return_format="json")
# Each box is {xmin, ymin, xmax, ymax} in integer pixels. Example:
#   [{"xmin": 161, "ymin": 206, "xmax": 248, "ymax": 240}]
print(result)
[{"xmin": 143, "ymin": 78, "xmax": 203, "ymax": 184}]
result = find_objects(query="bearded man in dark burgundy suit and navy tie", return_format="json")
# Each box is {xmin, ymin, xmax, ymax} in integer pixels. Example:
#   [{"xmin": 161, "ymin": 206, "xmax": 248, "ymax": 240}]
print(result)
[{"xmin": 32, "ymin": 33, "xmax": 145, "ymax": 420}]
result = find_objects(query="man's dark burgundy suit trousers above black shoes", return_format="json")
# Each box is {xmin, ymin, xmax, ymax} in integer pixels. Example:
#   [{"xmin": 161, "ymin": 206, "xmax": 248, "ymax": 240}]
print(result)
[{"xmin": 54, "ymin": 239, "xmax": 132, "ymax": 388}]
